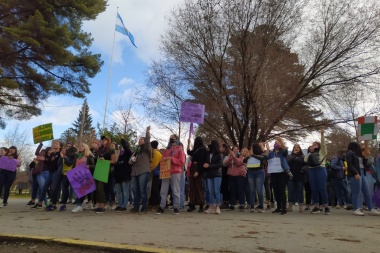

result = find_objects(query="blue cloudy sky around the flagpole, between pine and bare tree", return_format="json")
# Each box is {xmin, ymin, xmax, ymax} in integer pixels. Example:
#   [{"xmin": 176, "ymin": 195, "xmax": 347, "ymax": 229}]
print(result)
[{"xmin": 0, "ymin": 0, "xmax": 181, "ymax": 149}]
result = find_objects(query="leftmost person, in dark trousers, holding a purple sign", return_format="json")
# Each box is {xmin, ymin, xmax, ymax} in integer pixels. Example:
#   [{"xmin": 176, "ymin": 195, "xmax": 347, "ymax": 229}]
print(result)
[{"xmin": 0, "ymin": 146, "xmax": 21, "ymax": 207}]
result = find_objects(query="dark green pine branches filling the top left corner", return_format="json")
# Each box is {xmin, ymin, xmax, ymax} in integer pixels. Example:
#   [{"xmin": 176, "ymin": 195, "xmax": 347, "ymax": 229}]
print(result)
[{"xmin": 0, "ymin": 0, "xmax": 107, "ymax": 126}]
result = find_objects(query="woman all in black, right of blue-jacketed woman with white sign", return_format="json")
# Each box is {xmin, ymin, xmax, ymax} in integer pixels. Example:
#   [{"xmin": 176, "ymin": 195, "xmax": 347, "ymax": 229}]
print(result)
[{"xmin": 287, "ymin": 144, "xmax": 306, "ymax": 213}]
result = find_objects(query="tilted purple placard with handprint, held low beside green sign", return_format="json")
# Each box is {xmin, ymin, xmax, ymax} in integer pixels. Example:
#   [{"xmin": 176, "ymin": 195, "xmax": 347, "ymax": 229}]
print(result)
[{"xmin": 66, "ymin": 164, "xmax": 95, "ymax": 198}]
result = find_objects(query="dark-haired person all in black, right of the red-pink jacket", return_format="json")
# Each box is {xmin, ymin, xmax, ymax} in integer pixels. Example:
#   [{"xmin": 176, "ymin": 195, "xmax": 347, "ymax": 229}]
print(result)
[{"xmin": 187, "ymin": 136, "xmax": 208, "ymax": 213}]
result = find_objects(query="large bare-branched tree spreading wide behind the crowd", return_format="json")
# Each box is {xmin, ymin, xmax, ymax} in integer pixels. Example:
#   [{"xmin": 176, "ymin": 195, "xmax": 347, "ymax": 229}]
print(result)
[{"xmin": 148, "ymin": 0, "xmax": 380, "ymax": 147}]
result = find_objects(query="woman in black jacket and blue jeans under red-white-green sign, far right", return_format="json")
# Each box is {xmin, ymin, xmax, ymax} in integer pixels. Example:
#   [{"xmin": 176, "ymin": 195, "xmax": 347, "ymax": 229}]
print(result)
[{"xmin": 346, "ymin": 142, "xmax": 380, "ymax": 216}]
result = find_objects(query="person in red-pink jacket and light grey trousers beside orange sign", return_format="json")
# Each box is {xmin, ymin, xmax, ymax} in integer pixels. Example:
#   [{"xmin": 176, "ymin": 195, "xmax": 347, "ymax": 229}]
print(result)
[{"xmin": 156, "ymin": 134, "xmax": 186, "ymax": 214}]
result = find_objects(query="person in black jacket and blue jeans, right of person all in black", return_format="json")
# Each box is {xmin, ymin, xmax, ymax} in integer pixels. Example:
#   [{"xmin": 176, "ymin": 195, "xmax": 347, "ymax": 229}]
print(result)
[{"xmin": 203, "ymin": 140, "xmax": 223, "ymax": 214}]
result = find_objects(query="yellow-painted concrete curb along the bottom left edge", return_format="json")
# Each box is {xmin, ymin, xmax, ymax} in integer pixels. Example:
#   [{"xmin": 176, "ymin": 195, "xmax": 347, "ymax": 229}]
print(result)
[{"xmin": 0, "ymin": 234, "xmax": 192, "ymax": 253}]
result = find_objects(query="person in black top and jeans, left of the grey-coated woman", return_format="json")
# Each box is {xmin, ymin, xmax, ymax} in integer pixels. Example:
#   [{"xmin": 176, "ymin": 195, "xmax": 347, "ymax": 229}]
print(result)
[{"xmin": 114, "ymin": 139, "xmax": 133, "ymax": 212}]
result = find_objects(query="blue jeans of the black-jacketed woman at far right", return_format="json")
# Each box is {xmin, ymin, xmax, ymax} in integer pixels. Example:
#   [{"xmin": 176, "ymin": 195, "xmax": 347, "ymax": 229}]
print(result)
[{"xmin": 350, "ymin": 169, "xmax": 373, "ymax": 211}]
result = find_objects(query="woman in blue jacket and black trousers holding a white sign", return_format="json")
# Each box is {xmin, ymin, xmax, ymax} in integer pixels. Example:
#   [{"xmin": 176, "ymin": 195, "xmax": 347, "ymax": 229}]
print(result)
[{"xmin": 267, "ymin": 137, "xmax": 293, "ymax": 215}]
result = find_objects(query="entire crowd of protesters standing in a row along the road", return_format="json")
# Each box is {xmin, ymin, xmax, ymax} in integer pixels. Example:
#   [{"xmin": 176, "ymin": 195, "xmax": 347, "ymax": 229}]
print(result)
[{"xmin": 0, "ymin": 127, "xmax": 380, "ymax": 216}]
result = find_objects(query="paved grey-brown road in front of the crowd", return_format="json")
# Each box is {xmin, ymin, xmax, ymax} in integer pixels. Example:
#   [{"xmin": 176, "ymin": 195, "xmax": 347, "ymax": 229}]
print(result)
[{"xmin": 0, "ymin": 199, "xmax": 380, "ymax": 253}]
